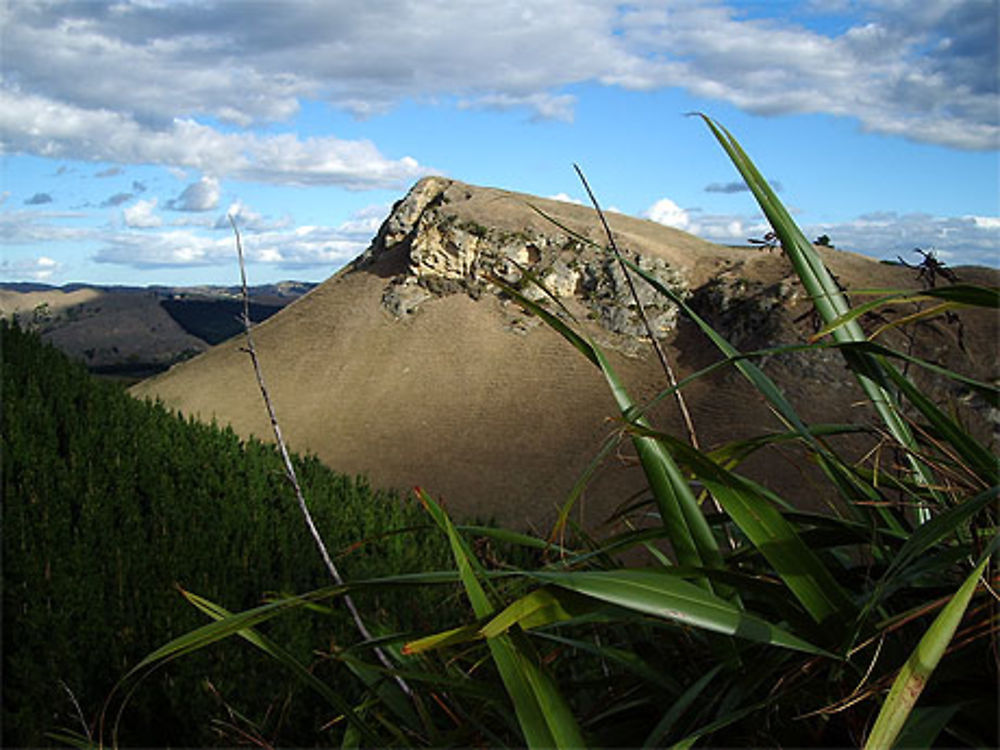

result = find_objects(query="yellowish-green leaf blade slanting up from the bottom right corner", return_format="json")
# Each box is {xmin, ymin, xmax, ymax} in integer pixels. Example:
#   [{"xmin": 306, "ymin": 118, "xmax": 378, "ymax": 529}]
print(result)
[{"xmin": 864, "ymin": 544, "xmax": 995, "ymax": 750}]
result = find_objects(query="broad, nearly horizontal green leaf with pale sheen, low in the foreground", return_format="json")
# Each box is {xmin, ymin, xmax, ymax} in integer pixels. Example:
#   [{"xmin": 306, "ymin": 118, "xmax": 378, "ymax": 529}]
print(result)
[{"xmin": 529, "ymin": 569, "xmax": 830, "ymax": 655}]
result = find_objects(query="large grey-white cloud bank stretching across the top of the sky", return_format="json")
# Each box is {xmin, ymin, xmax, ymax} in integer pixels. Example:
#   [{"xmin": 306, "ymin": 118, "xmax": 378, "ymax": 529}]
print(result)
[{"xmin": 0, "ymin": 0, "xmax": 1000, "ymax": 179}]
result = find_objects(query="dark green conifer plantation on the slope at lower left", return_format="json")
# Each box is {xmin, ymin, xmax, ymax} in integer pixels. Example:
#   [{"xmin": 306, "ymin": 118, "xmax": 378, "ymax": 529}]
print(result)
[{"xmin": 0, "ymin": 323, "xmax": 447, "ymax": 747}]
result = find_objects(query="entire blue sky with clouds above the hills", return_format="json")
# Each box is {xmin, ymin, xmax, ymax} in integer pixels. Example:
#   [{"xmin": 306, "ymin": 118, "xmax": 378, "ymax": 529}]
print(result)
[{"xmin": 0, "ymin": 0, "xmax": 1000, "ymax": 285}]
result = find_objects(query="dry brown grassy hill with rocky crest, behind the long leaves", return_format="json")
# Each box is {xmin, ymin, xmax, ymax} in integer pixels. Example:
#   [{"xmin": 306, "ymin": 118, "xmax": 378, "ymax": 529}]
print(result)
[{"xmin": 133, "ymin": 178, "xmax": 996, "ymax": 528}]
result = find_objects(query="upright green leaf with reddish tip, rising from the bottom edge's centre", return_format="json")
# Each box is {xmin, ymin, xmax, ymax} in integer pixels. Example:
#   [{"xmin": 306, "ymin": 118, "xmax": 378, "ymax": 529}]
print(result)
[{"xmin": 417, "ymin": 489, "xmax": 584, "ymax": 748}]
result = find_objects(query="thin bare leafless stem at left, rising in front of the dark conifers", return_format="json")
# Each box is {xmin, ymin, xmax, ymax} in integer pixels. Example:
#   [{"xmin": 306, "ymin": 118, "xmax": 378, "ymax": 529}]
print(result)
[{"xmin": 229, "ymin": 216, "xmax": 413, "ymax": 695}]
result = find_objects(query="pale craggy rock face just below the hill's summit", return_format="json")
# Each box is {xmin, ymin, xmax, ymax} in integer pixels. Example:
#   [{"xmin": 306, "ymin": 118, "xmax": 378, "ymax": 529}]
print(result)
[{"xmin": 356, "ymin": 177, "xmax": 688, "ymax": 349}]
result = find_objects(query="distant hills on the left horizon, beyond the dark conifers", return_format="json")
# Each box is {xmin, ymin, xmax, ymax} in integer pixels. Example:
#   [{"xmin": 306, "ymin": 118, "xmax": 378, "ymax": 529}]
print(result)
[{"xmin": 0, "ymin": 282, "xmax": 314, "ymax": 378}]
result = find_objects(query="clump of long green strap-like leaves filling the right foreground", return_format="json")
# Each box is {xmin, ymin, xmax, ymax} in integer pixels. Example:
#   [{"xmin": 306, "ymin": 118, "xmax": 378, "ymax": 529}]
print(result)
[{"xmin": 135, "ymin": 118, "xmax": 1000, "ymax": 748}]
